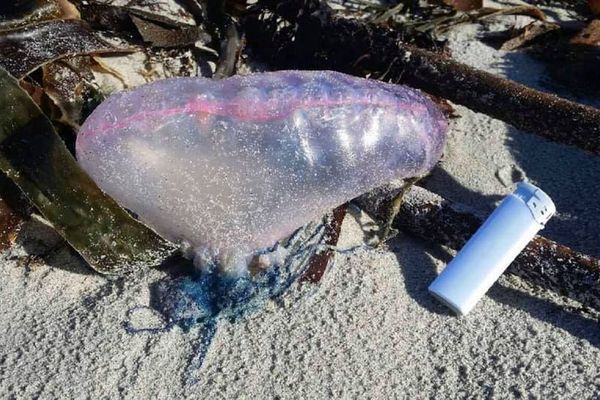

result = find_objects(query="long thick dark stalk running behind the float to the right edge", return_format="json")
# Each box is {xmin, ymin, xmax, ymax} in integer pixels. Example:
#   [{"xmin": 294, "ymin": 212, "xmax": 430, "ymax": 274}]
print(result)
[{"xmin": 242, "ymin": 0, "xmax": 600, "ymax": 154}]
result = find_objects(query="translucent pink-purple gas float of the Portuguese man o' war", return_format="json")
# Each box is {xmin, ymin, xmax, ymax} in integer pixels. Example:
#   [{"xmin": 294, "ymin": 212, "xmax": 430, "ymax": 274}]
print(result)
[{"xmin": 76, "ymin": 71, "xmax": 447, "ymax": 276}]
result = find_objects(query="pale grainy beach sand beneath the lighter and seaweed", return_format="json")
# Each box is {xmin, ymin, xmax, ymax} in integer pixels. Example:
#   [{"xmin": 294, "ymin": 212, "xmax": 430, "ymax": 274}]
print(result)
[{"xmin": 0, "ymin": 1, "xmax": 600, "ymax": 399}]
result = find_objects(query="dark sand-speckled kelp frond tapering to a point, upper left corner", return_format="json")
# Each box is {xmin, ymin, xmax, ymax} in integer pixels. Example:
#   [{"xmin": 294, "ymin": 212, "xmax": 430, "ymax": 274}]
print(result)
[{"xmin": 0, "ymin": 20, "xmax": 135, "ymax": 79}]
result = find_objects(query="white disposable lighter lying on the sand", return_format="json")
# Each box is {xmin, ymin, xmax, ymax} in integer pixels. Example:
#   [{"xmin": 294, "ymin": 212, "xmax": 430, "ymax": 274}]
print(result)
[{"xmin": 429, "ymin": 182, "xmax": 556, "ymax": 315}]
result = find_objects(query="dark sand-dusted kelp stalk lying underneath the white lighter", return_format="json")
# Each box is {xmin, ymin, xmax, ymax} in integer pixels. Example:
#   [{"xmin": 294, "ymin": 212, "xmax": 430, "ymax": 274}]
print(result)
[{"xmin": 357, "ymin": 186, "xmax": 600, "ymax": 312}]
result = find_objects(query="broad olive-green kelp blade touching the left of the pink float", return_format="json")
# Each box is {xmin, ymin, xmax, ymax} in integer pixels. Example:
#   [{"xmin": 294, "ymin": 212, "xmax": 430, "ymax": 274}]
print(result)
[{"xmin": 0, "ymin": 69, "xmax": 172, "ymax": 273}]
